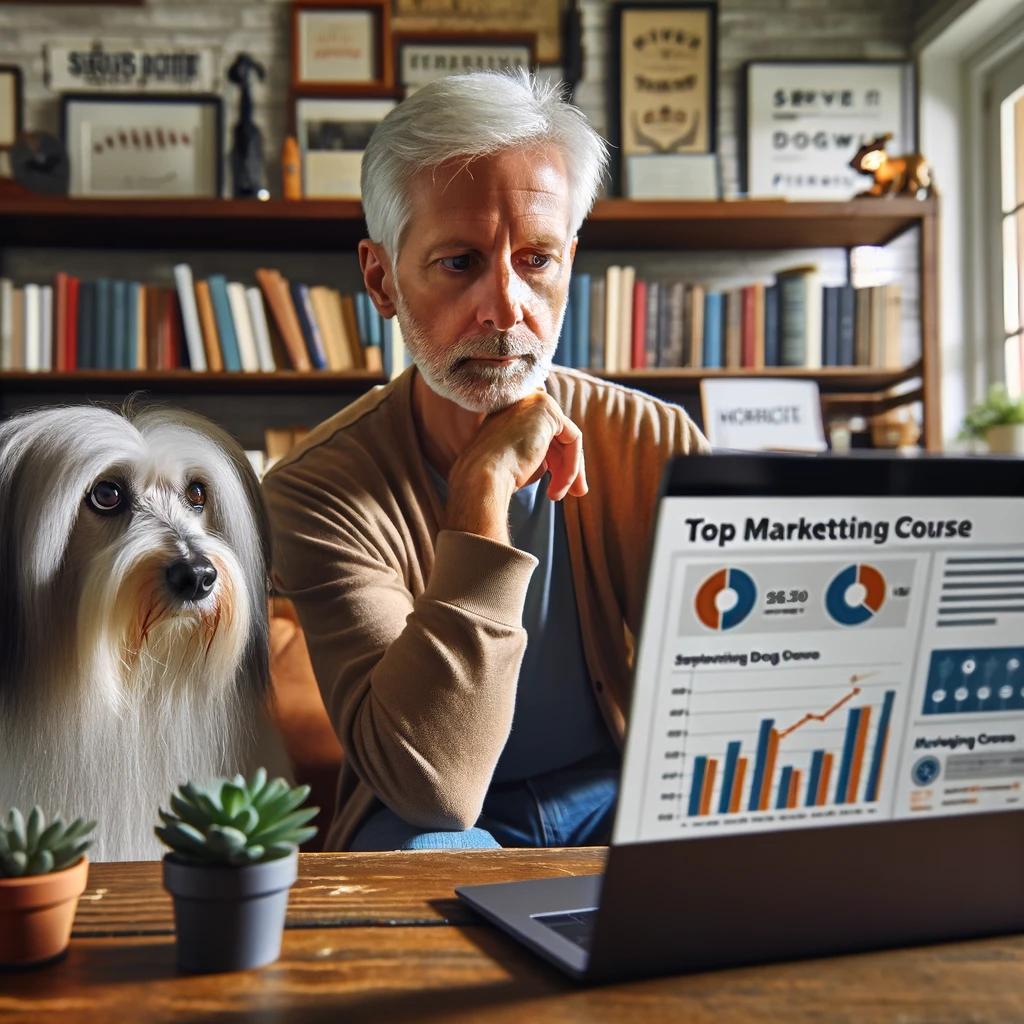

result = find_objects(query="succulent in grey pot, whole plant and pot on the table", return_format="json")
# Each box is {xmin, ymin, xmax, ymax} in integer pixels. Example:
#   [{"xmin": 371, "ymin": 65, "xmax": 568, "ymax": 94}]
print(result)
[{"xmin": 156, "ymin": 768, "xmax": 319, "ymax": 974}]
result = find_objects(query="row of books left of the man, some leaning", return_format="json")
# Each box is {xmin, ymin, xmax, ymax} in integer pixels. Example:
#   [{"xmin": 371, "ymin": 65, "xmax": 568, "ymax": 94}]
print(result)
[{"xmin": 0, "ymin": 263, "xmax": 391, "ymax": 373}]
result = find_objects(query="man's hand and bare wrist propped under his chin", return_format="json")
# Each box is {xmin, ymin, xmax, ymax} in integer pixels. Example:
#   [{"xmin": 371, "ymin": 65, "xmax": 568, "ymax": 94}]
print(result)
[{"xmin": 445, "ymin": 391, "xmax": 587, "ymax": 544}]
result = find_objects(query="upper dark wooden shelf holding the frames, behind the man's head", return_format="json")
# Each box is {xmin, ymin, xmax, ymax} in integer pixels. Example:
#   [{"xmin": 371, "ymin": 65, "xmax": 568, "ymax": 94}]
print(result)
[{"xmin": 0, "ymin": 197, "xmax": 937, "ymax": 252}]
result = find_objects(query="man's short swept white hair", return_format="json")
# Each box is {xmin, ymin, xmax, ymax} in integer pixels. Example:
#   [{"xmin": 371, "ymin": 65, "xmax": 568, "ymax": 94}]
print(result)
[{"xmin": 361, "ymin": 71, "xmax": 608, "ymax": 261}]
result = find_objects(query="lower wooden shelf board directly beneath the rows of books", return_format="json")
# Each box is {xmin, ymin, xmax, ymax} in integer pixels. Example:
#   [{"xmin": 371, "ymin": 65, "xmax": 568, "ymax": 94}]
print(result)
[{"xmin": 0, "ymin": 365, "xmax": 921, "ymax": 394}]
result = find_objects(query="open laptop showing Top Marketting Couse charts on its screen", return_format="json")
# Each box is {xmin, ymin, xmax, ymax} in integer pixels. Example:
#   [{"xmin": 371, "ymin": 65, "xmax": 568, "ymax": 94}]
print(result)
[{"xmin": 456, "ymin": 455, "xmax": 1024, "ymax": 983}]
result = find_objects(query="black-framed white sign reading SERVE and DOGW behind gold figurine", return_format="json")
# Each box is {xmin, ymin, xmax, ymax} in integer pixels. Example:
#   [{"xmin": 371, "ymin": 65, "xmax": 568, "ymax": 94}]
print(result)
[{"xmin": 739, "ymin": 60, "xmax": 916, "ymax": 200}]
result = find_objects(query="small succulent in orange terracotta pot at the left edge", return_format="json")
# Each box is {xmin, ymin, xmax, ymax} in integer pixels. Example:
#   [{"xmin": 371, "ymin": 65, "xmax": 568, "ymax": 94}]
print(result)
[{"xmin": 0, "ymin": 807, "xmax": 96, "ymax": 968}]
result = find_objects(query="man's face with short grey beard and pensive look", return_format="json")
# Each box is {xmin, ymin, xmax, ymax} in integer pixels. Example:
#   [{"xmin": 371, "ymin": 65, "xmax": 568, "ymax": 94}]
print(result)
[{"xmin": 394, "ymin": 148, "xmax": 575, "ymax": 413}]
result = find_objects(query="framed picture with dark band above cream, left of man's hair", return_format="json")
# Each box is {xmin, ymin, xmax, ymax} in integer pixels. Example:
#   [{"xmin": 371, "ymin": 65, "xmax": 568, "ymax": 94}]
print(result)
[{"xmin": 295, "ymin": 96, "xmax": 398, "ymax": 199}]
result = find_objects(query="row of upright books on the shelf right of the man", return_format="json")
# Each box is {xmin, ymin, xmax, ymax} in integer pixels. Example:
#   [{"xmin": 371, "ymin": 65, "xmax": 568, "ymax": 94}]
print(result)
[{"xmin": 555, "ymin": 266, "xmax": 902, "ymax": 373}]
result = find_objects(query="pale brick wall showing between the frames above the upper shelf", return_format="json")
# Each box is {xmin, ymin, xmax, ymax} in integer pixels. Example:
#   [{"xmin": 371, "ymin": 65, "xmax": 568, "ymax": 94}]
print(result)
[{"xmin": 0, "ymin": 0, "xmax": 922, "ymax": 195}]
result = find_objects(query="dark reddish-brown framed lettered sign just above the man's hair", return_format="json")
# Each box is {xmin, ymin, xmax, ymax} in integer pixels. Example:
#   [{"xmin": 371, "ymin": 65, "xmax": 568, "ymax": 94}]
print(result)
[{"xmin": 394, "ymin": 32, "xmax": 537, "ymax": 96}]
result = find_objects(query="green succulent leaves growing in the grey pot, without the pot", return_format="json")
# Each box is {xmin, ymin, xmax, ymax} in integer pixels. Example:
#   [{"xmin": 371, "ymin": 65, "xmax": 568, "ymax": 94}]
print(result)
[{"xmin": 155, "ymin": 768, "xmax": 319, "ymax": 866}]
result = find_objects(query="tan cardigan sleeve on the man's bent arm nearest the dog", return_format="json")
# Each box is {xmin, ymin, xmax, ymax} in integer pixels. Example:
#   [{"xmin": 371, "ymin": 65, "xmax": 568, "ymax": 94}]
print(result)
[{"xmin": 264, "ymin": 467, "xmax": 537, "ymax": 829}]
